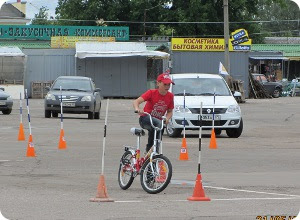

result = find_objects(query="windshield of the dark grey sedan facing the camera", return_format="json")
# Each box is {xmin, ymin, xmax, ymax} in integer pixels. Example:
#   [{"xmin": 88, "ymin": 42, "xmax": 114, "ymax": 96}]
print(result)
[{"xmin": 52, "ymin": 78, "xmax": 92, "ymax": 91}]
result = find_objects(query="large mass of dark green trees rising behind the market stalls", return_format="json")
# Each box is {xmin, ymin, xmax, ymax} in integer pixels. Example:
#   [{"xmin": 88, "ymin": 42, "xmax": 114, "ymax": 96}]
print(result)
[{"xmin": 56, "ymin": 0, "xmax": 299, "ymax": 43}]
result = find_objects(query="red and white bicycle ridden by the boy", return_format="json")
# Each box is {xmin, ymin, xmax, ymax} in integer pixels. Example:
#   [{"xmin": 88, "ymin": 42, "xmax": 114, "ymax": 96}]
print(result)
[{"xmin": 118, "ymin": 112, "xmax": 172, "ymax": 194}]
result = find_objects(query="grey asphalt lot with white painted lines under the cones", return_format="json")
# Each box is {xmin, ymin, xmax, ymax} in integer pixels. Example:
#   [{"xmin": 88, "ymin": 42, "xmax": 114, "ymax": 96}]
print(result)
[{"xmin": 0, "ymin": 97, "xmax": 300, "ymax": 220}]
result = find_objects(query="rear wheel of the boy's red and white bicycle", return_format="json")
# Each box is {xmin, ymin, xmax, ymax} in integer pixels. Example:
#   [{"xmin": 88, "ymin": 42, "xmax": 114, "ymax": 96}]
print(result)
[{"xmin": 118, "ymin": 151, "xmax": 134, "ymax": 190}]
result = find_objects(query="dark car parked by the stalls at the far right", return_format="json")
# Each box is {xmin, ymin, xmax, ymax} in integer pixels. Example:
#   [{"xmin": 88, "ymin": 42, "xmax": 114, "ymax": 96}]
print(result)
[{"xmin": 252, "ymin": 73, "xmax": 282, "ymax": 98}]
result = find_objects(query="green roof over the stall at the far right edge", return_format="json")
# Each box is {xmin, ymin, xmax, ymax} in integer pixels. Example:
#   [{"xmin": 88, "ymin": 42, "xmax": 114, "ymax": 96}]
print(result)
[{"xmin": 251, "ymin": 44, "xmax": 300, "ymax": 57}]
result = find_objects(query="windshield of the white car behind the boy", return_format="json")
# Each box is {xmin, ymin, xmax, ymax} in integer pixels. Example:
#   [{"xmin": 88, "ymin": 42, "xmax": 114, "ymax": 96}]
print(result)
[{"xmin": 172, "ymin": 78, "xmax": 231, "ymax": 96}]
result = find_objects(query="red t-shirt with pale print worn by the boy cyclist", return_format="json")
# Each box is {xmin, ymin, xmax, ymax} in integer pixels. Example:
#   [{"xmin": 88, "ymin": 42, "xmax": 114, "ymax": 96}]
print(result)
[{"xmin": 141, "ymin": 89, "xmax": 174, "ymax": 120}]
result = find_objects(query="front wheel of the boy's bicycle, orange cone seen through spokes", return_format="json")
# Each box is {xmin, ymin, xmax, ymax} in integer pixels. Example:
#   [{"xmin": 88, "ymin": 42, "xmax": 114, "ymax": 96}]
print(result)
[{"xmin": 141, "ymin": 155, "xmax": 172, "ymax": 194}]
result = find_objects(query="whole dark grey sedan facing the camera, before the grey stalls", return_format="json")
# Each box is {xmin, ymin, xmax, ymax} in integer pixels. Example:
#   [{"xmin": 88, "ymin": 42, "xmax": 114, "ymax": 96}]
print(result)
[{"xmin": 45, "ymin": 76, "xmax": 101, "ymax": 119}]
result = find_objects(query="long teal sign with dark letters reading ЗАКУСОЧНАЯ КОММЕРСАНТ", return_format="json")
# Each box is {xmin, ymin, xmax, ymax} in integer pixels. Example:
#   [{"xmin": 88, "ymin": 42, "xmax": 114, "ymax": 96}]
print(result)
[{"xmin": 0, "ymin": 25, "xmax": 129, "ymax": 41}]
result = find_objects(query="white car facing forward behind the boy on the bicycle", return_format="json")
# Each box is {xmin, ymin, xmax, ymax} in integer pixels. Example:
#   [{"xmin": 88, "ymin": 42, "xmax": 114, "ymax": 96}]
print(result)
[{"xmin": 166, "ymin": 73, "xmax": 243, "ymax": 138}]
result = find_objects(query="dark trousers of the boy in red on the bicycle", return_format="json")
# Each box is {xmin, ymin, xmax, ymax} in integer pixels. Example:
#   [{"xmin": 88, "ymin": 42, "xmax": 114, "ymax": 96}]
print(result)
[{"xmin": 139, "ymin": 115, "xmax": 162, "ymax": 152}]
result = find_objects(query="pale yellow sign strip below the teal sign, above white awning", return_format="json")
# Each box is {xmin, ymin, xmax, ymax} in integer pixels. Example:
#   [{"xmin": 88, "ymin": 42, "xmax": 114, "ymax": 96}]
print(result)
[{"xmin": 51, "ymin": 37, "xmax": 115, "ymax": 48}]
